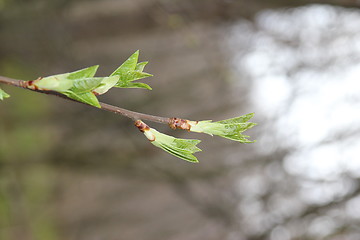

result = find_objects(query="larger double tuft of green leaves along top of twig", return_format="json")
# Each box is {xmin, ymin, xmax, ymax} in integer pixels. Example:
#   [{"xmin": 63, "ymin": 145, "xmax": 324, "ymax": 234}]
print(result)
[{"xmin": 33, "ymin": 51, "xmax": 152, "ymax": 108}]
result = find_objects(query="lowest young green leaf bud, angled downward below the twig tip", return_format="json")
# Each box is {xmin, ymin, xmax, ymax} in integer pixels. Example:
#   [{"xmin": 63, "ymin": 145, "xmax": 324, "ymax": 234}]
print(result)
[{"xmin": 144, "ymin": 128, "xmax": 201, "ymax": 163}]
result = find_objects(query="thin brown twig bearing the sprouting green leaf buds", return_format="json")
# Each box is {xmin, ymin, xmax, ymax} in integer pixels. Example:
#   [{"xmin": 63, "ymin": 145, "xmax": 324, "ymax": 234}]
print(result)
[{"xmin": 0, "ymin": 76, "xmax": 171, "ymax": 124}]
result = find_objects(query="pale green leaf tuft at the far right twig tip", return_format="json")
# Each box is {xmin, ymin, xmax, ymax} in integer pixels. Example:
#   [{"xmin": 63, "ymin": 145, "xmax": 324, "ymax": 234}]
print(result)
[{"xmin": 189, "ymin": 113, "xmax": 256, "ymax": 143}]
